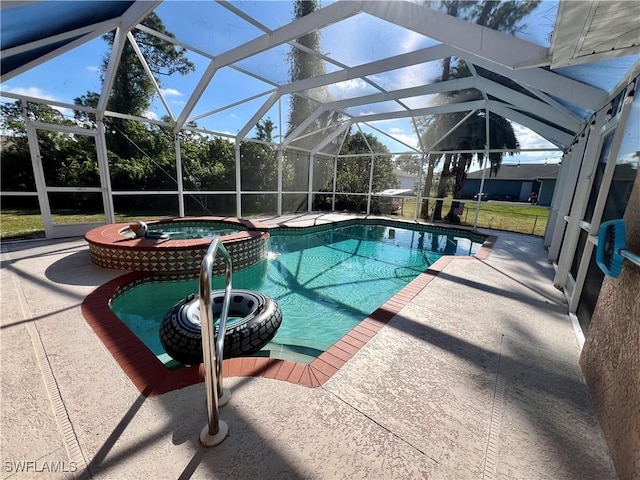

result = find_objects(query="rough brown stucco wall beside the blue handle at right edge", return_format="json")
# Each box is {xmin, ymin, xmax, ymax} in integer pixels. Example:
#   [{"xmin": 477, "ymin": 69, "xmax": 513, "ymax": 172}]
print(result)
[{"xmin": 580, "ymin": 166, "xmax": 640, "ymax": 480}]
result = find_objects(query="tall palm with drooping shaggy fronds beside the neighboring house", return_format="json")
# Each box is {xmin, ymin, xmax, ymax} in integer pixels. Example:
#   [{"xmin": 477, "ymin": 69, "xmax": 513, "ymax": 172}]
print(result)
[{"xmin": 420, "ymin": 0, "xmax": 540, "ymax": 223}]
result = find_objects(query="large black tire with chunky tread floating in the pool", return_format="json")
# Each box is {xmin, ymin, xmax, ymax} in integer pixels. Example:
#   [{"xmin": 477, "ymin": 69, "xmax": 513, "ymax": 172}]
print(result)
[{"xmin": 160, "ymin": 290, "xmax": 282, "ymax": 365}]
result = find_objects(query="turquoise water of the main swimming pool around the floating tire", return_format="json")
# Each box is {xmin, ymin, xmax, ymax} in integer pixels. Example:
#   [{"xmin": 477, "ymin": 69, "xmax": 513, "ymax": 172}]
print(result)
[{"xmin": 111, "ymin": 225, "xmax": 482, "ymax": 363}]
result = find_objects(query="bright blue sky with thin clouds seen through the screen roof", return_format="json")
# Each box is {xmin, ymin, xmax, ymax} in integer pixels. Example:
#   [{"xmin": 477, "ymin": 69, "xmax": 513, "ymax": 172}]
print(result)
[{"xmin": 0, "ymin": 0, "xmax": 608, "ymax": 171}]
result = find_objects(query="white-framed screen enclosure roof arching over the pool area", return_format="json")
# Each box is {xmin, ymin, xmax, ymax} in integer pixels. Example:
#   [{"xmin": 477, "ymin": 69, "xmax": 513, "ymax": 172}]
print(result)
[{"xmin": 1, "ymin": 0, "xmax": 640, "ymax": 152}]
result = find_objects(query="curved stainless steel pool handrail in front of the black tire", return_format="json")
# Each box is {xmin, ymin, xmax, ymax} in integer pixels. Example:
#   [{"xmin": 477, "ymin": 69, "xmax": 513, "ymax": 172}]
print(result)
[{"xmin": 200, "ymin": 238, "xmax": 232, "ymax": 447}]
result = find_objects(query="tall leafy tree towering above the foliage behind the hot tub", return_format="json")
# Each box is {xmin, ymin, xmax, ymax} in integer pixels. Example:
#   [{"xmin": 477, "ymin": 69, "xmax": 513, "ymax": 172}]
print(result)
[{"xmin": 69, "ymin": 13, "xmax": 195, "ymax": 210}]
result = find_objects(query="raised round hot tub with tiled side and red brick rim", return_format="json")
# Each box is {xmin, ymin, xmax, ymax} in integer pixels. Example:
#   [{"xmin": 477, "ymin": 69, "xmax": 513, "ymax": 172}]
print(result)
[{"xmin": 84, "ymin": 217, "xmax": 269, "ymax": 275}]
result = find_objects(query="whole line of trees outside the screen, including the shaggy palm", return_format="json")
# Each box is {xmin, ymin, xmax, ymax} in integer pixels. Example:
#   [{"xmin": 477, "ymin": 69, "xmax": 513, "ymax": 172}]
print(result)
[{"xmin": 0, "ymin": 0, "xmax": 539, "ymax": 222}]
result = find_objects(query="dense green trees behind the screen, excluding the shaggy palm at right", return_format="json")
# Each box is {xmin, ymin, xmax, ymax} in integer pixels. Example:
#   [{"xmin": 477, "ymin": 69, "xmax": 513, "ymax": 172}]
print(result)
[{"xmin": 0, "ymin": 6, "xmax": 397, "ymax": 217}]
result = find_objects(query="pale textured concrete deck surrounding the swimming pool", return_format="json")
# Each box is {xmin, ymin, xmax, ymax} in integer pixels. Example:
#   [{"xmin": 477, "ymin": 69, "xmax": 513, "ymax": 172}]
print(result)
[{"xmin": 0, "ymin": 215, "xmax": 616, "ymax": 479}]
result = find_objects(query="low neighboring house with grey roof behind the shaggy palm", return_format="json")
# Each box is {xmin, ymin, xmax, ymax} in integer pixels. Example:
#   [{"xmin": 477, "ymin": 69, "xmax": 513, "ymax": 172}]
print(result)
[{"xmin": 461, "ymin": 163, "xmax": 560, "ymax": 206}]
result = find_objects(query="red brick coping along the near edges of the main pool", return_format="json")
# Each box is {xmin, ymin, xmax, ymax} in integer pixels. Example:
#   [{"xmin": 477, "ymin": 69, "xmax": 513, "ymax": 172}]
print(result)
[{"xmin": 81, "ymin": 227, "xmax": 496, "ymax": 396}]
